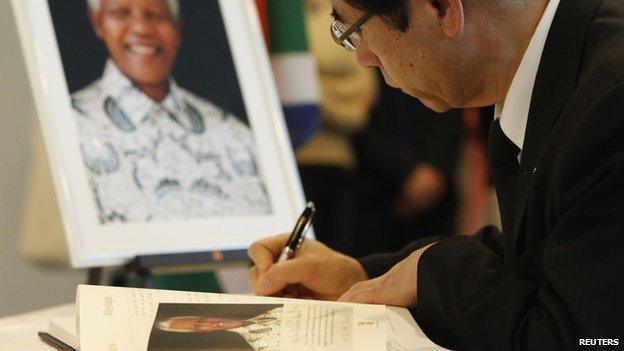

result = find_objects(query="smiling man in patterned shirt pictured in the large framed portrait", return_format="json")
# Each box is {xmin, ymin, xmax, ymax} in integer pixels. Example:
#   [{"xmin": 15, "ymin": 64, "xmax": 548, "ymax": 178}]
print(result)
[{"xmin": 72, "ymin": 0, "xmax": 271, "ymax": 224}]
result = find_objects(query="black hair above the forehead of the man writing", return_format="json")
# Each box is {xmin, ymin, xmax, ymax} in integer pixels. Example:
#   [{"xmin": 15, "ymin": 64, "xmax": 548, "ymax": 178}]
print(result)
[{"xmin": 345, "ymin": 0, "xmax": 409, "ymax": 32}]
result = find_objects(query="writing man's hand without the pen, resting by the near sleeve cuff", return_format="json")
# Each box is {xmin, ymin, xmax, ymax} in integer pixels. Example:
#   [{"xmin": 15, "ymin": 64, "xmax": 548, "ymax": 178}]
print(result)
[{"xmin": 339, "ymin": 244, "xmax": 433, "ymax": 307}]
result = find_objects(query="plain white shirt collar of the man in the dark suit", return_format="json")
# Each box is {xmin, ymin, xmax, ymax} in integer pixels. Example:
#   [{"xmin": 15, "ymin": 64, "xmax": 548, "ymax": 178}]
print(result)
[{"xmin": 494, "ymin": 0, "xmax": 559, "ymax": 150}]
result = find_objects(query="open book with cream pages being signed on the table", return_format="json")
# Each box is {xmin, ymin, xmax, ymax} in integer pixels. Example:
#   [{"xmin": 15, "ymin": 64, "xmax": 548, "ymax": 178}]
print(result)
[{"xmin": 49, "ymin": 285, "xmax": 443, "ymax": 351}]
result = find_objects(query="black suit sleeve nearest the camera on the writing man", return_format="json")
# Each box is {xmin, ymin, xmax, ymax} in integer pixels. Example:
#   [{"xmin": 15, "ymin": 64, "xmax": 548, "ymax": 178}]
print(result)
[{"xmin": 416, "ymin": 86, "xmax": 624, "ymax": 351}]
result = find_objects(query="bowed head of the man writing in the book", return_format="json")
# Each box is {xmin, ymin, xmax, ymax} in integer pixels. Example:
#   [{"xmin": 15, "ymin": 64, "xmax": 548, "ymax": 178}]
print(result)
[{"xmin": 332, "ymin": 0, "xmax": 545, "ymax": 112}]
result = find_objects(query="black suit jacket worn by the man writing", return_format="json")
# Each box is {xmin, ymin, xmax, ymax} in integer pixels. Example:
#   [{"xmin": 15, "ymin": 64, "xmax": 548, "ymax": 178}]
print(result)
[{"xmin": 361, "ymin": 0, "xmax": 624, "ymax": 351}]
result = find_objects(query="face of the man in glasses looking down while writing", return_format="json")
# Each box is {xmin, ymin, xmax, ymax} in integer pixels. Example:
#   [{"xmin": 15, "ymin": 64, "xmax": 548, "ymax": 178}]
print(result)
[{"xmin": 332, "ymin": 0, "xmax": 488, "ymax": 112}]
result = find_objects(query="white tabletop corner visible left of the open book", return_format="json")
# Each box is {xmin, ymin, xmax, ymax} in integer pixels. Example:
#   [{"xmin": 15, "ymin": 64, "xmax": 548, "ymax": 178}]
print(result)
[{"xmin": 0, "ymin": 303, "xmax": 75, "ymax": 351}]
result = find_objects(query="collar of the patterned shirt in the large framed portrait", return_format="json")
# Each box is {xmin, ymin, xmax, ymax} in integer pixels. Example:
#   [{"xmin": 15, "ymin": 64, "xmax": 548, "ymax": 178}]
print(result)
[{"xmin": 101, "ymin": 59, "xmax": 186, "ymax": 125}]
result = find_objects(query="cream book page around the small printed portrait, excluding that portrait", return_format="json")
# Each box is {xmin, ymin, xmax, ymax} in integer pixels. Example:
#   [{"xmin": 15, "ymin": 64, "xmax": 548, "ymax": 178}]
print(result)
[{"xmin": 77, "ymin": 285, "xmax": 387, "ymax": 351}]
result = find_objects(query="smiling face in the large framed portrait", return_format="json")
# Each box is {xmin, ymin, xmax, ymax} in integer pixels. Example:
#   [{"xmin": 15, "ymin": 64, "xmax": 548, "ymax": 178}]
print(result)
[{"xmin": 90, "ymin": 0, "xmax": 181, "ymax": 85}]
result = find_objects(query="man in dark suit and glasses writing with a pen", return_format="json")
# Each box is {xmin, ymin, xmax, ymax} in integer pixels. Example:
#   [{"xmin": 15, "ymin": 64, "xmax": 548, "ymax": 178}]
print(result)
[{"xmin": 250, "ymin": 0, "xmax": 624, "ymax": 351}]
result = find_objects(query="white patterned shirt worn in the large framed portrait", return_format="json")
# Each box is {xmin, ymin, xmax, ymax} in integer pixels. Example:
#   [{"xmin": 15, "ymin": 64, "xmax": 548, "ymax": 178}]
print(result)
[{"xmin": 72, "ymin": 60, "xmax": 271, "ymax": 224}]
